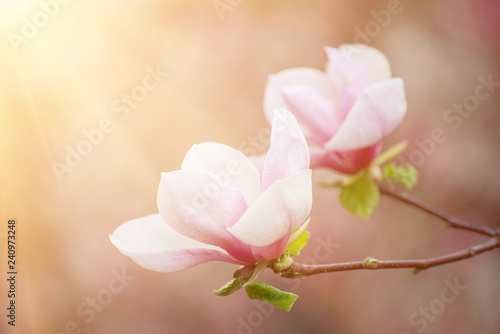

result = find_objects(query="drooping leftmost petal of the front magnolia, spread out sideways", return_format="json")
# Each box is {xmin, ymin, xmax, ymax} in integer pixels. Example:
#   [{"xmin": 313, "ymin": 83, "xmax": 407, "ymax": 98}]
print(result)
[{"xmin": 109, "ymin": 214, "xmax": 245, "ymax": 272}]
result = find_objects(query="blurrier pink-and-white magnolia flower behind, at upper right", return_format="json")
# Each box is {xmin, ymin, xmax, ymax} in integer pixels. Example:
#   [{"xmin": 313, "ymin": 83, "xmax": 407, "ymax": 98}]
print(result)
[{"xmin": 264, "ymin": 45, "xmax": 406, "ymax": 174}]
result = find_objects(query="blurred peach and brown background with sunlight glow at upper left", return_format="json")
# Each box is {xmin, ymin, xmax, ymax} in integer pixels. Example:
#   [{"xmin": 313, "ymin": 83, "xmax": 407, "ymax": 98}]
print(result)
[{"xmin": 0, "ymin": 0, "xmax": 500, "ymax": 334}]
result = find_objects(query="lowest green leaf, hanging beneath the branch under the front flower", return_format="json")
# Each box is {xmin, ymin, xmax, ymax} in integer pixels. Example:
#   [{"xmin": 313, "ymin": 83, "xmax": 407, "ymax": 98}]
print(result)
[{"xmin": 245, "ymin": 282, "xmax": 299, "ymax": 312}]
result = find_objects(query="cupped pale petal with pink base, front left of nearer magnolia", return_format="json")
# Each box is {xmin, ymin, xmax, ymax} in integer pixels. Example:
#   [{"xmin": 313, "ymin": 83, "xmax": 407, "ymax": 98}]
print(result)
[{"xmin": 158, "ymin": 170, "xmax": 254, "ymax": 262}]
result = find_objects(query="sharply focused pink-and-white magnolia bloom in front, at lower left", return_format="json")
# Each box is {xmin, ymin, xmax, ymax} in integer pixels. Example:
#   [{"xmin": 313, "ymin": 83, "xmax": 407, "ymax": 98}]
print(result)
[{"xmin": 110, "ymin": 110, "xmax": 312, "ymax": 272}]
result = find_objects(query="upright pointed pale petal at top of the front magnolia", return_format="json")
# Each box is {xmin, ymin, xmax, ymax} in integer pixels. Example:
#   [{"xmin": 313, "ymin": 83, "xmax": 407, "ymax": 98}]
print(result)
[{"xmin": 262, "ymin": 109, "xmax": 309, "ymax": 190}]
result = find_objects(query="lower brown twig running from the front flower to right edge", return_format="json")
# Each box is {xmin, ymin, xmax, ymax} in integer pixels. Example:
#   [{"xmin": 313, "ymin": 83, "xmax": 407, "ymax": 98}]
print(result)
[{"xmin": 276, "ymin": 236, "xmax": 500, "ymax": 278}]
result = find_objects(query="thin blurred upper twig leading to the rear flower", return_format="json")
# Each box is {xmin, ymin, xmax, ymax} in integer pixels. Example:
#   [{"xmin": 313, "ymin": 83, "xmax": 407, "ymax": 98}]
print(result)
[{"xmin": 380, "ymin": 188, "xmax": 500, "ymax": 236}]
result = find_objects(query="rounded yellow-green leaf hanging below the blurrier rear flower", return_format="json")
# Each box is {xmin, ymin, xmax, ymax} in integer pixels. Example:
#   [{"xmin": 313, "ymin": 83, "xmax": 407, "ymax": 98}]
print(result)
[{"xmin": 339, "ymin": 175, "xmax": 380, "ymax": 219}]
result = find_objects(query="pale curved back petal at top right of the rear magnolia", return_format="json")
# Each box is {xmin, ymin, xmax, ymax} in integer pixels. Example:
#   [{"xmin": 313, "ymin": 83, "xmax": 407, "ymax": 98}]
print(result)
[{"xmin": 339, "ymin": 44, "xmax": 391, "ymax": 82}]
